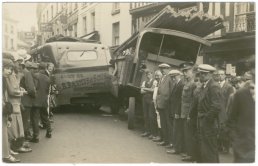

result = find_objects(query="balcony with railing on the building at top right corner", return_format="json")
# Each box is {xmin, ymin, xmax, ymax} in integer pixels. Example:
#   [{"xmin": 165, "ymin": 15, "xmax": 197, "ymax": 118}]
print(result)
[{"xmin": 235, "ymin": 11, "xmax": 255, "ymax": 32}]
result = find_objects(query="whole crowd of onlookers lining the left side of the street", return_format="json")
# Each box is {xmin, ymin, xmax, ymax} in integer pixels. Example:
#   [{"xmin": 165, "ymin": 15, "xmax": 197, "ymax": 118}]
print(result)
[{"xmin": 2, "ymin": 52, "xmax": 54, "ymax": 163}]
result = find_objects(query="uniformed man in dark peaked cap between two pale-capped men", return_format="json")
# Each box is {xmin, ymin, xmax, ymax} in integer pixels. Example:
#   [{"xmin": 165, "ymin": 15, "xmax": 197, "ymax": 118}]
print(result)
[{"xmin": 179, "ymin": 62, "xmax": 197, "ymax": 161}]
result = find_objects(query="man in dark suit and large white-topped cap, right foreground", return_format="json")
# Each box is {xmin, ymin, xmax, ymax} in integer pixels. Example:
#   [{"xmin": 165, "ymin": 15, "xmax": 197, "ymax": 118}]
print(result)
[{"xmin": 197, "ymin": 64, "xmax": 221, "ymax": 163}]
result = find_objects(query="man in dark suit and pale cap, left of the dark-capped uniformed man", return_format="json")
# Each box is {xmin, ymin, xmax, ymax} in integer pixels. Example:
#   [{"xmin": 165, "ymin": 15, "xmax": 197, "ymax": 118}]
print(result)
[{"xmin": 167, "ymin": 70, "xmax": 185, "ymax": 154}]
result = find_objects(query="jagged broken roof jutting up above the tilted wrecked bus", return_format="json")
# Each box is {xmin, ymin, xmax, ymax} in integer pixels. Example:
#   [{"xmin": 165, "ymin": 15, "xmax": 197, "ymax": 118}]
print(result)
[{"xmin": 114, "ymin": 6, "xmax": 224, "ymax": 53}]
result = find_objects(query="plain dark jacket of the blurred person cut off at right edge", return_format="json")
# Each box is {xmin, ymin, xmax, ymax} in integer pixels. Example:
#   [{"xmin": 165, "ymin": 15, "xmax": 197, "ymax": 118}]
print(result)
[{"xmin": 226, "ymin": 87, "xmax": 255, "ymax": 161}]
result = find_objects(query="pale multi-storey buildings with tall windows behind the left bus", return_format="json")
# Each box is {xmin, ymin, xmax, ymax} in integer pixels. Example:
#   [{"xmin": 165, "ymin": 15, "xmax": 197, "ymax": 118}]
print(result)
[{"xmin": 37, "ymin": 3, "xmax": 131, "ymax": 46}]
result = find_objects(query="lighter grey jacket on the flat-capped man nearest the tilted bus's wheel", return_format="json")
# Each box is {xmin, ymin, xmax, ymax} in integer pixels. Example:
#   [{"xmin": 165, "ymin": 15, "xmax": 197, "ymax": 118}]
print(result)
[{"xmin": 156, "ymin": 75, "xmax": 174, "ymax": 110}]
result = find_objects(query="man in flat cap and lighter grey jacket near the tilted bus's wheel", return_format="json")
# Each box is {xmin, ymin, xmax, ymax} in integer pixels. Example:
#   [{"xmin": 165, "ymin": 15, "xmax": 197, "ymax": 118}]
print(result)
[{"xmin": 156, "ymin": 63, "xmax": 173, "ymax": 146}]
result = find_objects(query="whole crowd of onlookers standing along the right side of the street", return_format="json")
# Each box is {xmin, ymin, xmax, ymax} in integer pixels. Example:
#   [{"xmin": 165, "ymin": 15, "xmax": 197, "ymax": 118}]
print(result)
[{"xmin": 141, "ymin": 62, "xmax": 255, "ymax": 163}]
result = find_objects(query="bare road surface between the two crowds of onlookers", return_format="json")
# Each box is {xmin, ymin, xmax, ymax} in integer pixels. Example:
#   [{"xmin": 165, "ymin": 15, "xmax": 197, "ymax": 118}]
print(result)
[{"xmin": 13, "ymin": 110, "xmax": 233, "ymax": 164}]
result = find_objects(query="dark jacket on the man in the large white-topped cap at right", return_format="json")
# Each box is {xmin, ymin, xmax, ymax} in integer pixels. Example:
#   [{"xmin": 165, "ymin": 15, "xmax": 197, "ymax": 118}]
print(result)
[{"xmin": 197, "ymin": 79, "xmax": 222, "ymax": 124}]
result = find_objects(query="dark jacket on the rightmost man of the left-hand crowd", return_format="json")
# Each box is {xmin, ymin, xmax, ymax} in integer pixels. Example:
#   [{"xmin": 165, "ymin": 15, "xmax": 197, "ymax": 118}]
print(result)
[{"xmin": 34, "ymin": 73, "xmax": 50, "ymax": 107}]
